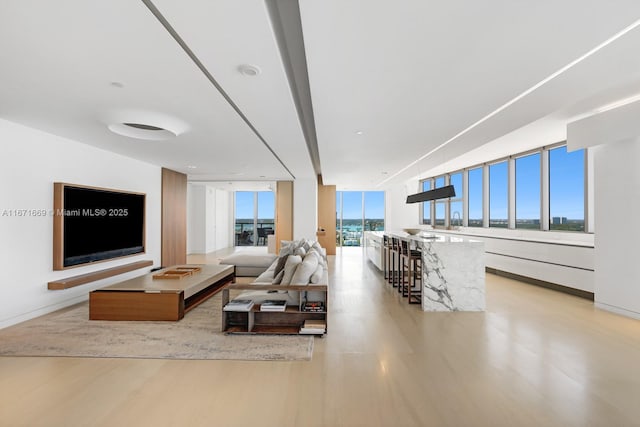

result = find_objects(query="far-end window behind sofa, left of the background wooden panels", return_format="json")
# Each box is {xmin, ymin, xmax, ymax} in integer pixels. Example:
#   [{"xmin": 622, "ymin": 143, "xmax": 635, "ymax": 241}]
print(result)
[{"xmin": 235, "ymin": 191, "xmax": 275, "ymax": 246}]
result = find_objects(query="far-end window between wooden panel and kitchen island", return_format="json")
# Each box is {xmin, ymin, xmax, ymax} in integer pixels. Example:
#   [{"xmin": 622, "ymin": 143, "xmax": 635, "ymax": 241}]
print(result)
[{"xmin": 336, "ymin": 191, "xmax": 384, "ymax": 246}]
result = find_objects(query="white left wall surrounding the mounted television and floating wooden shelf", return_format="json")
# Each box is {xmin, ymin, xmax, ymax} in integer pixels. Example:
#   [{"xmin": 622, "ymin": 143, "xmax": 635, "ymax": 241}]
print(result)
[{"xmin": 0, "ymin": 119, "xmax": 161, "ymax": 327}]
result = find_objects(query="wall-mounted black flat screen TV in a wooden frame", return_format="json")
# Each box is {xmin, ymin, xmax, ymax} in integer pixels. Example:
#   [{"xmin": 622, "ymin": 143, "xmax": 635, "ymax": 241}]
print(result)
[{"xmin": 53, "ymin": 182, "xmax": 145, "ymax": 270}]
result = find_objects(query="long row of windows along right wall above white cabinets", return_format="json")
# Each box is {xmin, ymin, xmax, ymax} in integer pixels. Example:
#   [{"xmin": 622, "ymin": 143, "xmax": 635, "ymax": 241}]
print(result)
[{"xmin": 420, "ymin": 143, "xmax": 592, "ymax": 231}]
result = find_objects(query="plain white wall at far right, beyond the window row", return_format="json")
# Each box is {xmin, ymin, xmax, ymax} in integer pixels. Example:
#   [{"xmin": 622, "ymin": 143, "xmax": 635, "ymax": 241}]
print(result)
[{"xmin": 593, "ymin": 140, "xmax": 640, "ymax": 318}]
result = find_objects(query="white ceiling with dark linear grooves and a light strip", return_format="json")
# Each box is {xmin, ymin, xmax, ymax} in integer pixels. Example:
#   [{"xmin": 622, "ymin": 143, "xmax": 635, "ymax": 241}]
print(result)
[{"xmin": 0, "ymin": 0, "xmax": 640, "ymax": 189}]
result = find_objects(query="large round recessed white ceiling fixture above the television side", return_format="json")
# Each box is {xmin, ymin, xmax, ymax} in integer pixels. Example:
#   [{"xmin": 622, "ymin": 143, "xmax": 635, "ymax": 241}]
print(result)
[{"xmin": 105, "ymin": 110, "xmax": 189, "ymax": 141}]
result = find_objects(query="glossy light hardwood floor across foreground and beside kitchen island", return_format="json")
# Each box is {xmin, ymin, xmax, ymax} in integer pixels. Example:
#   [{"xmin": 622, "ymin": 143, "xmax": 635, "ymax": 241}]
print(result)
[{"xmin": 0, "ymin": 248, "xmax": 640, "ymax": 427}]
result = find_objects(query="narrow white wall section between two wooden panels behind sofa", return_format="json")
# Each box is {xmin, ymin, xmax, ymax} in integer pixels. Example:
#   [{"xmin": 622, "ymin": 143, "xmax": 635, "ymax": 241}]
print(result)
[{"xmin": 293, "ymin": 179, "xmax": 318, "ymax": 240}]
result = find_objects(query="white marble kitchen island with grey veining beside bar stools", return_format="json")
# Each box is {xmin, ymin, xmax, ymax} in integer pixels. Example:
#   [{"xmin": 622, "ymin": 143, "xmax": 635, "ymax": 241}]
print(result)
[{"xmin": 381, "ymin": 230, "xmax": 486, "ymax": 311}]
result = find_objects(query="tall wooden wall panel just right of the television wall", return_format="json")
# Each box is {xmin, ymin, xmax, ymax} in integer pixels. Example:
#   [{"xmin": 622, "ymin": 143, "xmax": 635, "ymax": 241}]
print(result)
[{"xmin": 162, "ymin": 168, "xmax": 187, "ymax": 267}]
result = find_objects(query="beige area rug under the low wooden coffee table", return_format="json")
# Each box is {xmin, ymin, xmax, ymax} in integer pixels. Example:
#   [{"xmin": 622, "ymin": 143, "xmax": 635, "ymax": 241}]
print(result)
[{"xmin": 0, "ymin": 293, "xmax": 313, "ymax": 360}]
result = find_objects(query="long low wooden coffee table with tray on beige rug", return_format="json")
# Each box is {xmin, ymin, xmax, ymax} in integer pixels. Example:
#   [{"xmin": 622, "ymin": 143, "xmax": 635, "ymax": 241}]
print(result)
[{"xmin": 89, "ymin": 264, "xmax": 235, "ymax": 321}]
